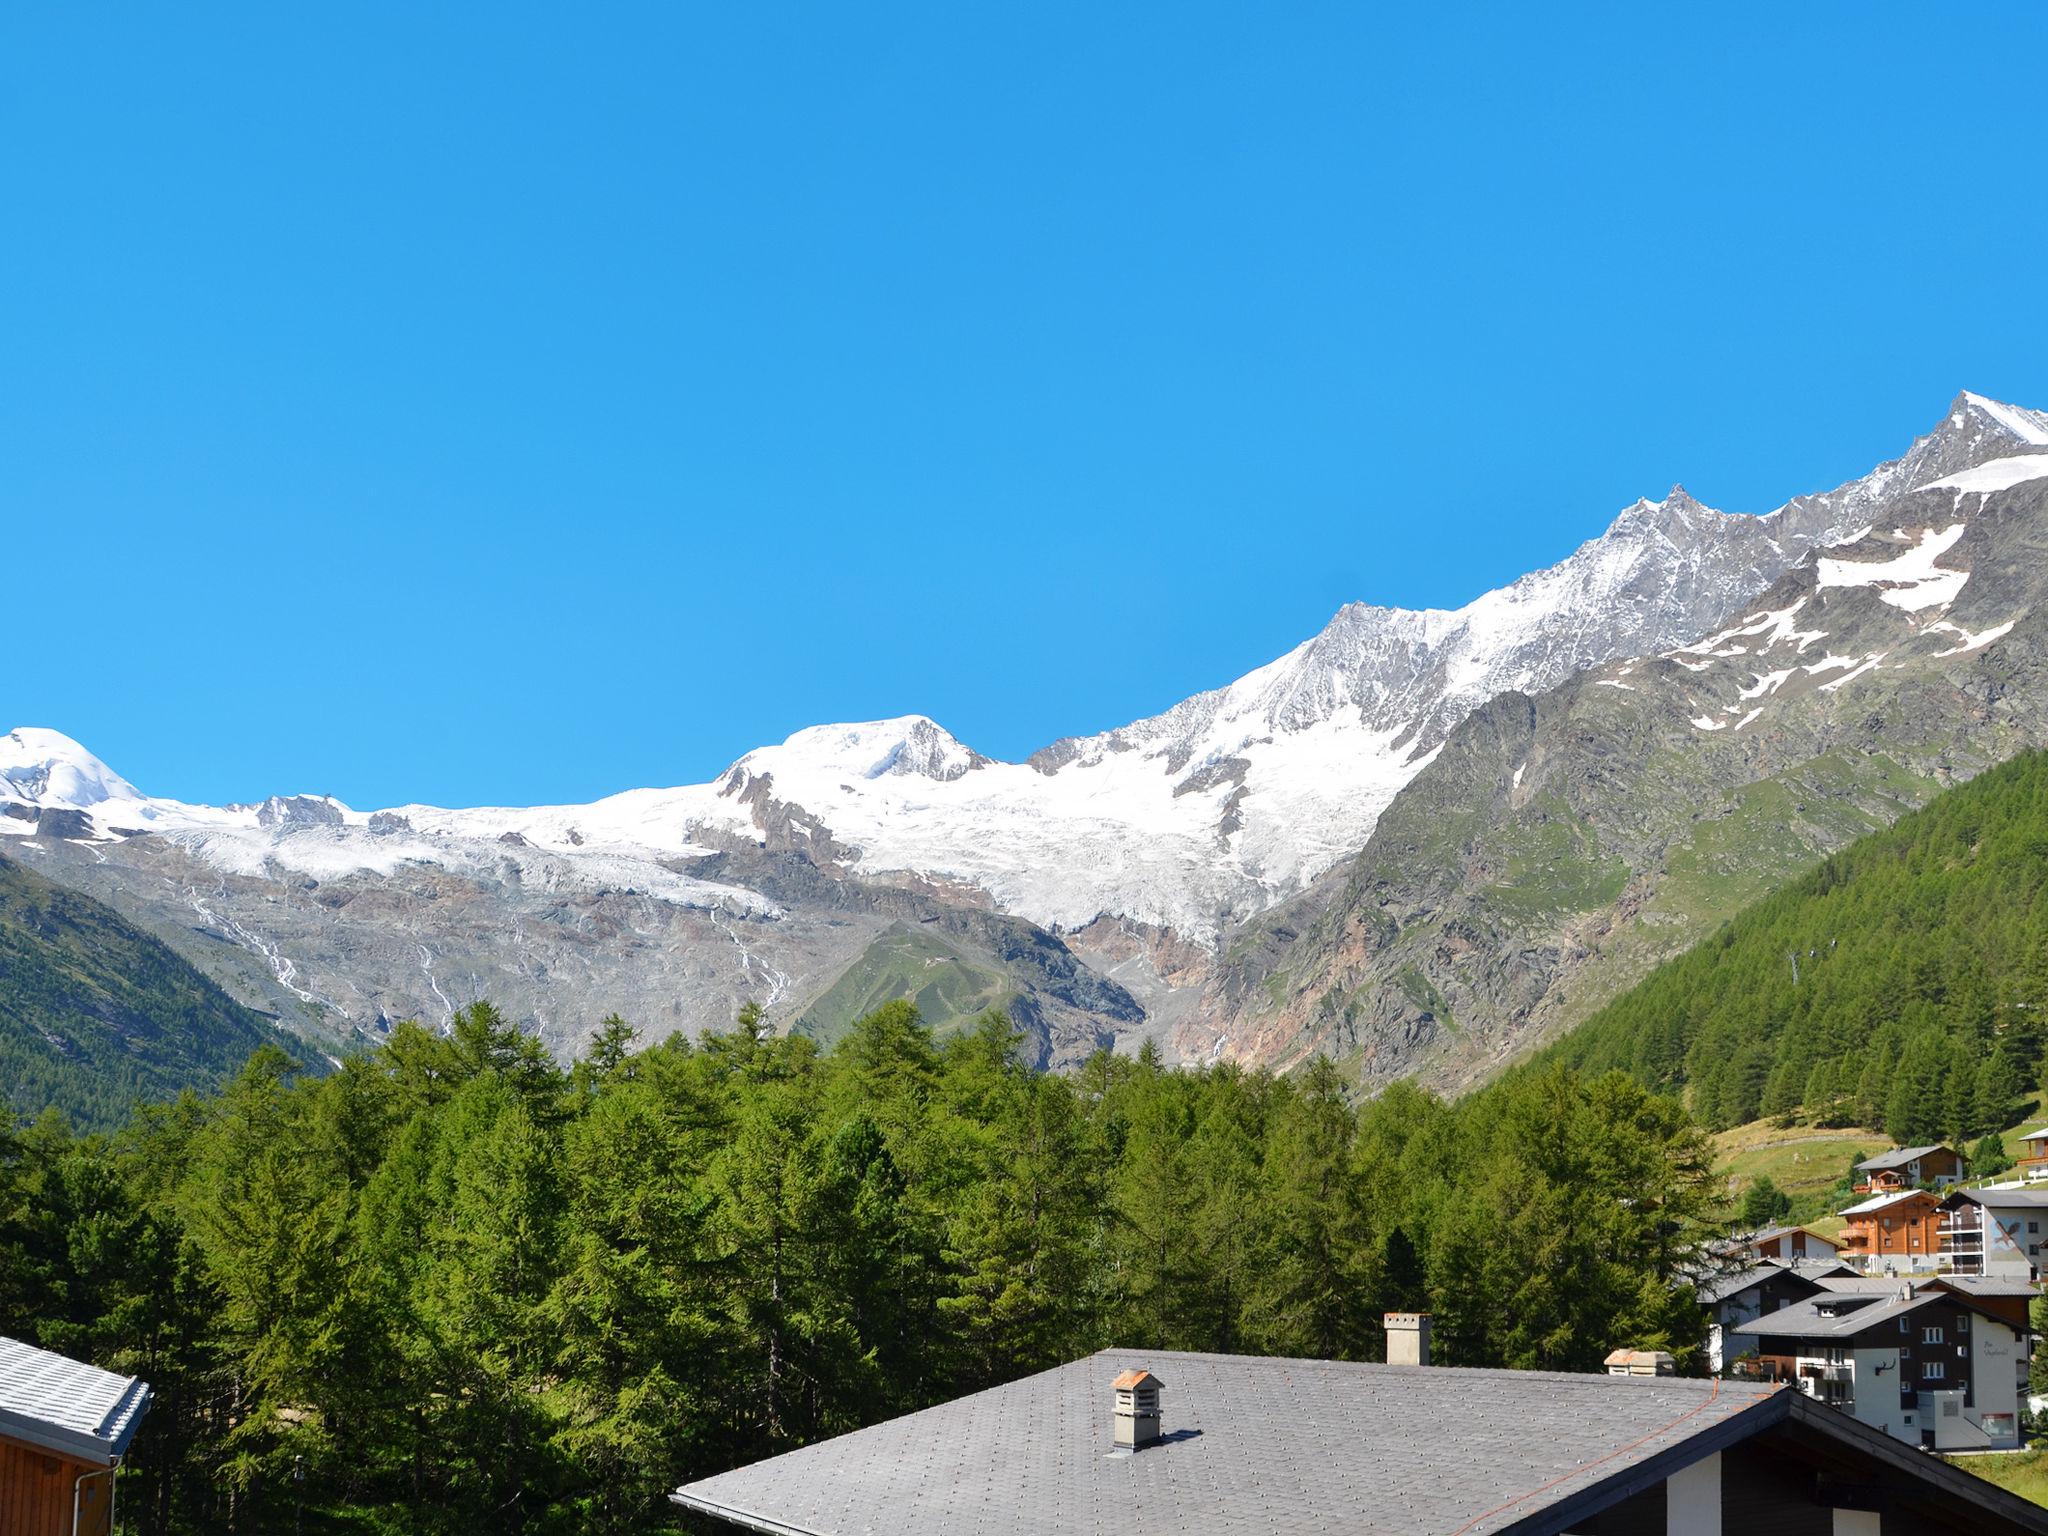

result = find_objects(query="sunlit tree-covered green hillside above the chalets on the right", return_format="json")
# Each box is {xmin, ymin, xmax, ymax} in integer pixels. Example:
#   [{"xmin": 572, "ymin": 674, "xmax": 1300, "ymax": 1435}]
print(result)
[{"xmin": 1546, "ymin": 752, "xmax": 2048, "ymax": 1143}]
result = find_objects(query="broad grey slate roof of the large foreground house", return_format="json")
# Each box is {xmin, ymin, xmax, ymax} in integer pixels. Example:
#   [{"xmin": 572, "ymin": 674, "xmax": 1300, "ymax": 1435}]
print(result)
[{"xmin": 676, "ymin": 1350, "xmax": 1794, "ymax": 1536}]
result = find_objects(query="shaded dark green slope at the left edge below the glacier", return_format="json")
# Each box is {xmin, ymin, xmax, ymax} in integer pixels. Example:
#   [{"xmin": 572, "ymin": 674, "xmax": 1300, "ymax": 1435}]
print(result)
[{"xmin": 0, "ymin": 858, "xmax": 301, "ymax": 1128}]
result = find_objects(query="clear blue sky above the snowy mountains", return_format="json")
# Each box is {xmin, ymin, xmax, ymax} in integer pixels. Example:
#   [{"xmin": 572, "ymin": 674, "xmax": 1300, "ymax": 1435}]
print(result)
[{"xmin": 0, "ymin": 2, "xmax": 2048, "ymax": 805}]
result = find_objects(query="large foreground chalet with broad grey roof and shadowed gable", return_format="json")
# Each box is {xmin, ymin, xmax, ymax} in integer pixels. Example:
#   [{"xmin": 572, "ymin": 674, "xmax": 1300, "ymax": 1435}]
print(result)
[{"xmin": 670, "ymin": 1351, "xmax": 2048, "ymax": 1536}]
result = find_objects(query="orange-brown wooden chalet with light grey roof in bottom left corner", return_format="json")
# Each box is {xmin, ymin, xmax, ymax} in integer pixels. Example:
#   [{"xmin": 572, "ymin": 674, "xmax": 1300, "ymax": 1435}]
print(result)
[{"xmin": 0, "ymin": 1337, "xmax": 150, "ymax": 1536}]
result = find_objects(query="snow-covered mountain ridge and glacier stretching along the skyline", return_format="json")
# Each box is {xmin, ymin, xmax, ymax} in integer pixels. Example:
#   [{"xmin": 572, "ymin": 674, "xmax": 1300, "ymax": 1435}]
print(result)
[{"xmin": 0, "ymin": 393, "xmax": 2048, "ymax": 942}]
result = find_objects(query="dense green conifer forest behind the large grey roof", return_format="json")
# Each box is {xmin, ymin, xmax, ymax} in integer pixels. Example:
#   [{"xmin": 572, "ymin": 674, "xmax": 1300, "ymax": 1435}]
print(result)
[{"xmin": 0, "ymin": 1004, "xmax": 1712, "ymax": 1532}]
